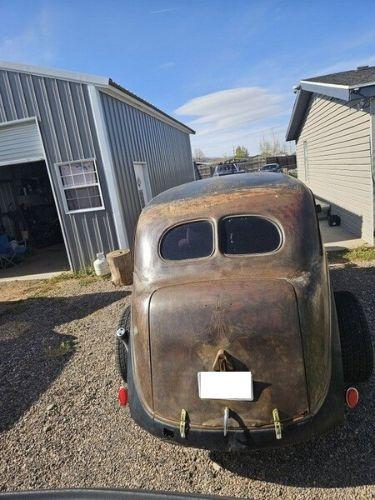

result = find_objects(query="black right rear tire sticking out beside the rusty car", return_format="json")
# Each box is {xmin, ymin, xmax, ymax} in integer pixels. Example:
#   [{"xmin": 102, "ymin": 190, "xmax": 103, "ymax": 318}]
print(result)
[{"xmin": 334, "ymin": 292, "xmax": 374, "ymax": 383}]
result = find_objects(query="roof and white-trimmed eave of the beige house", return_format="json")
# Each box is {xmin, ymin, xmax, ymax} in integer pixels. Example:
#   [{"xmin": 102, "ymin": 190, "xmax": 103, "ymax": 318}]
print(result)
[{"xmin": 286, "ymin": 66, "xmax": 375, "ymax": 141}]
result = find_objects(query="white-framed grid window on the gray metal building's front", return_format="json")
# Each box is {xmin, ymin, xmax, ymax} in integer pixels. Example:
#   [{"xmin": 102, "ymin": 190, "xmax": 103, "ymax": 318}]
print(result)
[{"xmin": 56, "ymin": 159, "xmax": 104, "ymax": 213}]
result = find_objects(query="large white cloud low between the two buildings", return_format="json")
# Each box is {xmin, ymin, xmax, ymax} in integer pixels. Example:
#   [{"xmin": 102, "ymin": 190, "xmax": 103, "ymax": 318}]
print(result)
[{"xmin": 175, "ymin": 87, "xmax": 289, "ymax": 155}]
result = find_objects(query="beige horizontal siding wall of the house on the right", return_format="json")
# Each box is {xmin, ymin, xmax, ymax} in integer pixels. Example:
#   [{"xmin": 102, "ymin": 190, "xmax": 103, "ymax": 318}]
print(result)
[{"xmin": 296, "ymin": 95, "xmax": 374, "ymax": 243}]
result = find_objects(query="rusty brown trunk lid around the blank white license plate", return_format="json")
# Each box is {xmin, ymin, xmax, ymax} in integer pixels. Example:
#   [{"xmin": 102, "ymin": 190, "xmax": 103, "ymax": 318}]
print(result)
[{"xmin": 150, "ymin": 279, "xmax": 308, "ymax": 428}]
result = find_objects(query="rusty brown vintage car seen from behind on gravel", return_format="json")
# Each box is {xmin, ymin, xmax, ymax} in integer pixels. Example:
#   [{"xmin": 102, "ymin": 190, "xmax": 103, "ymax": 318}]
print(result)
[{"xmin": 116, "ymin": 173, "xmax": 373, "ymax": 451}]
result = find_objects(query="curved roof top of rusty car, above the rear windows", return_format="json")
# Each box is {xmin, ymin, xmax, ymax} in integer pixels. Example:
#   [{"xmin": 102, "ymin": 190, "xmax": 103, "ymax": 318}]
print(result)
[{"xmin": 146, "ymin": 172, "xmax": 307, "ymax": 209}]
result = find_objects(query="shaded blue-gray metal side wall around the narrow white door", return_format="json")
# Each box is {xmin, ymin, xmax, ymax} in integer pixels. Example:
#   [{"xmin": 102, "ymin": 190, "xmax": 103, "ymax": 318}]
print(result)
[{"xmin": 100, "ymin": 92, "xmax": 194, "ymax": 242}]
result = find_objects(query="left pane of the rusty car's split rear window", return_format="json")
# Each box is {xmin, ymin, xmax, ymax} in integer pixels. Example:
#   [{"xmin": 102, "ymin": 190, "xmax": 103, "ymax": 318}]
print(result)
[{"xmin": 160, "ymin": 221, "xmax": 213, "ymax": 260}]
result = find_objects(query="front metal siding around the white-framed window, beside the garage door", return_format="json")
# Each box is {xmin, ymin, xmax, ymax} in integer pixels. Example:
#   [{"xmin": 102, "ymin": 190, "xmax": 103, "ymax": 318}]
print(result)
[{"xmin": 0, "ymin": 71, "xmax": 117, "ymax": 269}]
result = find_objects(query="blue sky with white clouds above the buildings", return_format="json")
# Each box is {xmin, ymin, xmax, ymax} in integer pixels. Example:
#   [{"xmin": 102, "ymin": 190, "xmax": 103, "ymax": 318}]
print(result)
[{"xmin": 0, "ymin": 0, "xmax": 375, "ymax": 155}]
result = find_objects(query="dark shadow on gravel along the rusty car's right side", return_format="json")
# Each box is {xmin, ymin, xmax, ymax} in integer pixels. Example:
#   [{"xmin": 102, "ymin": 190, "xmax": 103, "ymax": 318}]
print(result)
[{"xmin": 210, "ymin": 267, "xmax": 375, "ymax": 488}]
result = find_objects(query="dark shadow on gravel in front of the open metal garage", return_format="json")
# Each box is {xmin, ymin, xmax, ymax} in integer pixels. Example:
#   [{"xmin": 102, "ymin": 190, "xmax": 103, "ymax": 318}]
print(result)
[{"xmin": 0, "ymin": 291, "xmax": 130, "ymax": 432}]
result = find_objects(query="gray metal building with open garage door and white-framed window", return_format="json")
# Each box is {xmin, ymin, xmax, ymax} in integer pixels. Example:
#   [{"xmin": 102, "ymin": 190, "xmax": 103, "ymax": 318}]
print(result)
[{"xmin": 0, "ymin": 62, "xmax": 194, "ymax": 270}]
